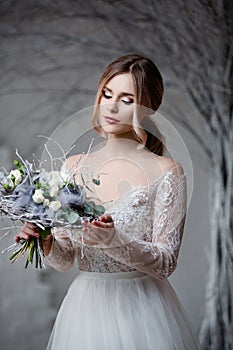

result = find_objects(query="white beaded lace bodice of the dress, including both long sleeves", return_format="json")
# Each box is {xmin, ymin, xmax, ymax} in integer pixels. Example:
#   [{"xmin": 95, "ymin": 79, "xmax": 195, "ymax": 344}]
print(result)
[{"xmin": 47, "ymin": 164, "xmax": 187, "ymax": 279}]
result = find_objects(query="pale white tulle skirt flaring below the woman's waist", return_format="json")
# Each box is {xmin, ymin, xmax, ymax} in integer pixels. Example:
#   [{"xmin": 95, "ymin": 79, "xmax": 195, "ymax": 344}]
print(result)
[{"xmin": 47, "ymin": 272, "xmax": 199, "ymax": 350}]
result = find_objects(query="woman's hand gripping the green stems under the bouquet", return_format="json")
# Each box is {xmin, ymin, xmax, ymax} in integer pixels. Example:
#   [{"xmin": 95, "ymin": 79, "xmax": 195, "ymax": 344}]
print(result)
[{"xmin": 15, "ymin": 221, "xmax": 53, "ymax": 255}]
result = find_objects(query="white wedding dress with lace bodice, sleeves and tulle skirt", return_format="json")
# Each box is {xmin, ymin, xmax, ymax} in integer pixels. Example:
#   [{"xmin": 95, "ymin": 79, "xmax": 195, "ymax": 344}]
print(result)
[{"xmin": 47, "ymin": 167, "xmax": 199, "ymax": 350}]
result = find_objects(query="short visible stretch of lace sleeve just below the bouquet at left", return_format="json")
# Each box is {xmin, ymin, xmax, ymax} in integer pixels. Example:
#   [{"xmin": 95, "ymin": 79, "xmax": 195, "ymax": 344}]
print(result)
[{"xmin": 46, "ymin": 228, "xmax": 75, "ymax": 271}]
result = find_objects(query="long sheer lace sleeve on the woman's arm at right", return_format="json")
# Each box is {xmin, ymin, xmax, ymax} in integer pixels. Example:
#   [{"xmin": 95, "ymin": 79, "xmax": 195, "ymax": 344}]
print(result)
[{"xmin": 103, "ymin": 165, "xmax": 187, "ymax": 279}]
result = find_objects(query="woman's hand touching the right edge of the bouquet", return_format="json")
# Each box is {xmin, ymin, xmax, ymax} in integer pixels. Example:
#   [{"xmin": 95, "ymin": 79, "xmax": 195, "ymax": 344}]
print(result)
[{"xmin": 82, "ymin": 214, "xmax": 115, "ymax": 246}]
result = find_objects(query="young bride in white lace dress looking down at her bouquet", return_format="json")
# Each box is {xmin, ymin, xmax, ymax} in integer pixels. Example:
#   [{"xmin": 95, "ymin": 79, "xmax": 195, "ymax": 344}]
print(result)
[{"xmin": 16, "ymin": 55, "xmax": 198, "ymax": 350}]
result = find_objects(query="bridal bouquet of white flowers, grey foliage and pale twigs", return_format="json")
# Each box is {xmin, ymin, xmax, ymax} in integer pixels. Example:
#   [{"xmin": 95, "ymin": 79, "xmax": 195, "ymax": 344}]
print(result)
[{"xmin": 0, "ymin": 151, "xmax": 104, "ymax": 268}]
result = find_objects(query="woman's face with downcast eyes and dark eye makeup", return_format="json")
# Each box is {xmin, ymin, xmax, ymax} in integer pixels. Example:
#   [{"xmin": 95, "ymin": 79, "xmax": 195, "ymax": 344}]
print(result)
[{"xmin": 99, "ymin": 73, "xmax": 136, "ymax": 137}]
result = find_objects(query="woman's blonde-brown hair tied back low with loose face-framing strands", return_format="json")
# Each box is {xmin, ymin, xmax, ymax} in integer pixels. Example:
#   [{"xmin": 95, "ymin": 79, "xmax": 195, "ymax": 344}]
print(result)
[{"xmin": 92, "ymin": 54, "xmax": 164, "ymax": 155}]
